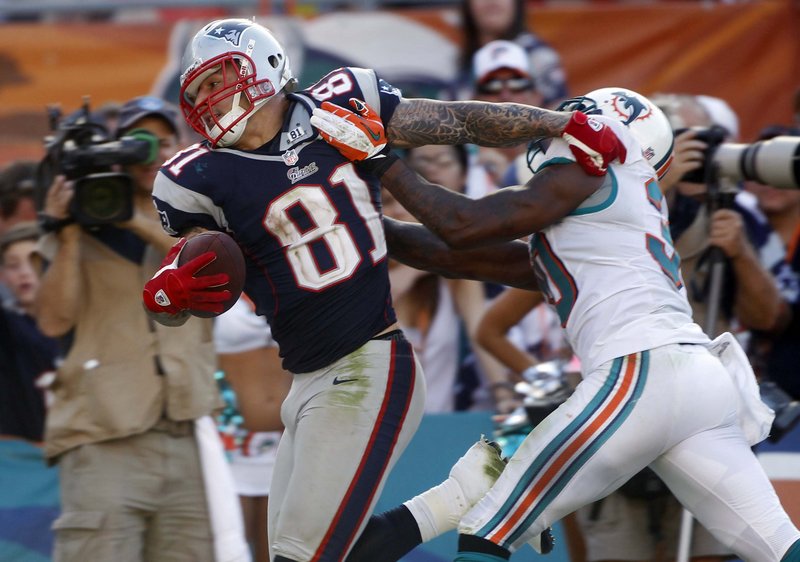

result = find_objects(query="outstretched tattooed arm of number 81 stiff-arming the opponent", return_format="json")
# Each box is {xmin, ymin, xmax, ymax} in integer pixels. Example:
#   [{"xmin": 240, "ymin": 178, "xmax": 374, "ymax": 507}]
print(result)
[{"xmin": 386, "ymin": 99, "xmax": 572, "ymax": 148}]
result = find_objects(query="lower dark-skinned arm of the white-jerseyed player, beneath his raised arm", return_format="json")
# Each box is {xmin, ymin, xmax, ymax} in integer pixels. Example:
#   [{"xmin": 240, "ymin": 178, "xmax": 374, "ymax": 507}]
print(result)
[{"xmin": 383, "ymin": 217, "xmax": 538, "ymax": 290}]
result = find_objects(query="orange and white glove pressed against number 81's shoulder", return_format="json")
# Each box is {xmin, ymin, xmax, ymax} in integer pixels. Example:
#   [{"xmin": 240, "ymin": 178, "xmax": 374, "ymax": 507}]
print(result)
[{"xmin": 311, "ymin": 98, "xmax": 386, "ymax": 162}]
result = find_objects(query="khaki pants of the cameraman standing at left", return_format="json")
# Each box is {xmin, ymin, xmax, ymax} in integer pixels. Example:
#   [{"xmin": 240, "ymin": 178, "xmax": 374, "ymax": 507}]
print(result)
[{"xmin": 53, "ymin": 422, "xmax": 214, "ymax": 562}]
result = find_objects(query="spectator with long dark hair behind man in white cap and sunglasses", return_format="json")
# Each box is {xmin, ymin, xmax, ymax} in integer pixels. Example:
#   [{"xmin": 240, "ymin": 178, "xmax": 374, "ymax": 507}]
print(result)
[{"xmin": 460, "ymin": 0, "xmax": 568, "ymax": 107}]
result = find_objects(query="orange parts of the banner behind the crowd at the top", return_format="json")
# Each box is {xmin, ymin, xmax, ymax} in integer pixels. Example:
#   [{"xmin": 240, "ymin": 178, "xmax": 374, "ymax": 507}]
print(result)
[{"xmin": 0, "ymin": 0, "xmax": 800, "ymax": 164}]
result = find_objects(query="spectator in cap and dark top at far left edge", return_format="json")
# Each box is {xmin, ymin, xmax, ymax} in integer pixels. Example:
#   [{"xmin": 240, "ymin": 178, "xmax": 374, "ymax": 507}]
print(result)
[{"xmin": 0, "ymin": 222, "xmax": 58, "ymax": 442}]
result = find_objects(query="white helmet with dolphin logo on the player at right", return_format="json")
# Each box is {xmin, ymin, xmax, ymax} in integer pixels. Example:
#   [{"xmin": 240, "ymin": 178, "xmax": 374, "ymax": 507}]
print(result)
[{"xmin": 558, "ymin": 88, "xmax": 675, "ymax": 179}]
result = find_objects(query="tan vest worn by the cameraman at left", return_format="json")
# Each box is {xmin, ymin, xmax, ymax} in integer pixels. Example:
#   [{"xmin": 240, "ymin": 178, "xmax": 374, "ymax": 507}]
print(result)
[{"xmin": 43, "ymin": 233, "xmax": 222, "ymax": 458}]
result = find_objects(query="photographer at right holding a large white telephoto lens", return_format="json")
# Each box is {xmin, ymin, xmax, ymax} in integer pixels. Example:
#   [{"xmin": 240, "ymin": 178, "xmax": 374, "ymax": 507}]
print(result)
[{"xmin": 654, "ymin": 94, "xmax": 780, "ymax": 337}]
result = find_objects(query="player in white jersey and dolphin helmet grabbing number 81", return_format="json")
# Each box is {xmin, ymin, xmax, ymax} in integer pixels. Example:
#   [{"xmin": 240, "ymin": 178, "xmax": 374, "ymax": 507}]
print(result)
[{"xmin": 312, "ymin": 88, "xmax": 800, "ymax": 562}]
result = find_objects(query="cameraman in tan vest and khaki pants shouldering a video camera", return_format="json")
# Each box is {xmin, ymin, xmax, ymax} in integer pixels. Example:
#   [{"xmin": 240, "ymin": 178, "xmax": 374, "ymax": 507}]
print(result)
[{"xmin": 36, "ymin": 97, "xmax": 234, "ymax": 562}]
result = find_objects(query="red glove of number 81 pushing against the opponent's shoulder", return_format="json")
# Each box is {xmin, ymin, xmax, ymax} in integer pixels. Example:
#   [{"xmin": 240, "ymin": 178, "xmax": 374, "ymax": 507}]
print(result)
[{"xmin": 561, "ymin": 111, "xmax": 628, "ymax": 176}]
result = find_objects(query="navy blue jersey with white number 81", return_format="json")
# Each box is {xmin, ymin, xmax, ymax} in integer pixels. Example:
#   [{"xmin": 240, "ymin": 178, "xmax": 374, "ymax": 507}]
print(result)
[{"xmin": 153, "ymin": 68, "xmax": 400, "ymax": 373}]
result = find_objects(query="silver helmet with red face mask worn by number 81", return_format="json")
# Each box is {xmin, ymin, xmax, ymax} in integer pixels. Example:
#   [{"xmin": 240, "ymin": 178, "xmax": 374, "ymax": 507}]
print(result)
[{"xmin": 180, "ymin": 18, "xmax": 296, "ymax": 146}]
